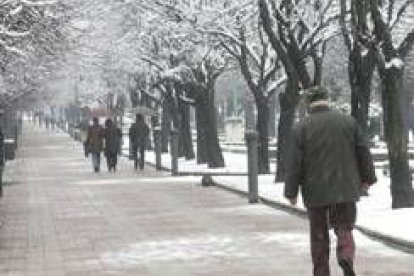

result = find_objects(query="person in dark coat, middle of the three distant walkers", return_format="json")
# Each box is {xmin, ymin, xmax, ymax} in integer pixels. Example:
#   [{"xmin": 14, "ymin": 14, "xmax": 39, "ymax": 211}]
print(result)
[{"xmin": 104, "ymin": 119, "xmax": 122, "ymax": 172}]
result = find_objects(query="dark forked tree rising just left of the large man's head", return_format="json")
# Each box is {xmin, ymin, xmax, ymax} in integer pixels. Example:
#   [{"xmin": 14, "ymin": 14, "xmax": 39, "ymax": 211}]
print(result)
[{"xmin": 258, "ymin": 0, "xmax": 339, "ymax": 181}]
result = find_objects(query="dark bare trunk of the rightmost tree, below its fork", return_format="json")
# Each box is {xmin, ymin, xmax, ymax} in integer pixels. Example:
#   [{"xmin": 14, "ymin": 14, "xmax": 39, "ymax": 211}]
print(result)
[{"xmin": 381, "ymin": 68, "xmax": 414, "ymax": 209}]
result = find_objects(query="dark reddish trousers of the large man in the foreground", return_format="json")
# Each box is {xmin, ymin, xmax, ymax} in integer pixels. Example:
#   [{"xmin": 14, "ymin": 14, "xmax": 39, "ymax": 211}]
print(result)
[{"xmin": 308, "ymin": 203, "xmax": 356, "ymax": 276}]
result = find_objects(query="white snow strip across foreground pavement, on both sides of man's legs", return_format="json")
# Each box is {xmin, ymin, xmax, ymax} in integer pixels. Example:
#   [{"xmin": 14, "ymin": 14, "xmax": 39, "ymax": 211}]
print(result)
[{"xmin": 94, "ymin": 231, "xmax": 399, "ymax": 269}]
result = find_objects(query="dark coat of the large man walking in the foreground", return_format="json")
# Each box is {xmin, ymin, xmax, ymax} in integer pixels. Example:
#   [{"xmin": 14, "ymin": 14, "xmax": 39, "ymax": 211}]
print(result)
[{"xmin": 285, "ymin": 106, "xmax": 376, "ymax": 208}]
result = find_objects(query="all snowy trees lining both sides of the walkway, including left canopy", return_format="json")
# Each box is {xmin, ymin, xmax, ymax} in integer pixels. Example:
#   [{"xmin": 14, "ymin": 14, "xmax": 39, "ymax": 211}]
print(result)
[{"xmin": 0, "ymin": 0, "xmax": 414, "ymax": 208}]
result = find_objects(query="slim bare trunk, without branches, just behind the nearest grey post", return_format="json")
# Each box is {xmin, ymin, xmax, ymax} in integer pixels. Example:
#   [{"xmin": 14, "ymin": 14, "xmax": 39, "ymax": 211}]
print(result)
[{"xmin": 256, "ymin": 98, "xmax": 270, "ymax": 174}]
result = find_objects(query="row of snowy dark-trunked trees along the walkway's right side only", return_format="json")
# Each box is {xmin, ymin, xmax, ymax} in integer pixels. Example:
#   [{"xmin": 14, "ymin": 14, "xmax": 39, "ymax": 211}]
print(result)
[{"xmin": 106, "ymin": 0, "xmax": 414, "ymax": 208}]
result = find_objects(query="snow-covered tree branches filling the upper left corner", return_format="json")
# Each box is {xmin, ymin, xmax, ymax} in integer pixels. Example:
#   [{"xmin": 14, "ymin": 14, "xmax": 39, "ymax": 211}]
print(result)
[{"xmin": 0, "ymin": 0, "xmax": 64, "ymax": 104}]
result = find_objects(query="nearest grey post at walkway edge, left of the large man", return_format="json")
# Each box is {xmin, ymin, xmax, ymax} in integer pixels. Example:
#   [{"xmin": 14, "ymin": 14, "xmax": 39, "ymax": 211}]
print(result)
[{"xmin": 244, "ymin": 130, "xmax": 259, "ymax": 203}]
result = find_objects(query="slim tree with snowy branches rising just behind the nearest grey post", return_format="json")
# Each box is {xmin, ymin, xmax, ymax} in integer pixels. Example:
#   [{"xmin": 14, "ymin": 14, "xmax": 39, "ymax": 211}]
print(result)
[{"xmin": 197, "ymin": 1, "xmax": 285, "ymax": 173}]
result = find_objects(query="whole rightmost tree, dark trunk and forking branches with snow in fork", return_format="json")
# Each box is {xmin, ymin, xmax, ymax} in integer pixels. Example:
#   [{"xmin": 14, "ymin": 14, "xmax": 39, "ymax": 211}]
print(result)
[{"xmin": 361, "ymin": 0, "xmax": 414, "ymax": 208}]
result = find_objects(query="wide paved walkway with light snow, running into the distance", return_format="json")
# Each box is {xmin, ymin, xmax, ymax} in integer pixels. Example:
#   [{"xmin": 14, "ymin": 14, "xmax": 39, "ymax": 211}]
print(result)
[{"xmin": 0, "ymin": 125, "xmax": 414, "ymax": 276}]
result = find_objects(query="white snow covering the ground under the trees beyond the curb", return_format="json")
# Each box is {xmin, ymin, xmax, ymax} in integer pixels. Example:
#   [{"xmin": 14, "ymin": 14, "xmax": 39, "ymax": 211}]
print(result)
[{"xmin": 139, "ymin": 148, "xmax": 414, "ymax": 243}]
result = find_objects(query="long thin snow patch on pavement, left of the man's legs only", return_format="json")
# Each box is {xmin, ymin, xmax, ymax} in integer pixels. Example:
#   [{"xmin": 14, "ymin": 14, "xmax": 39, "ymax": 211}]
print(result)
[{"xmin": 97, "ymin": 232, "xmax": 309, "ymax": 268}]
